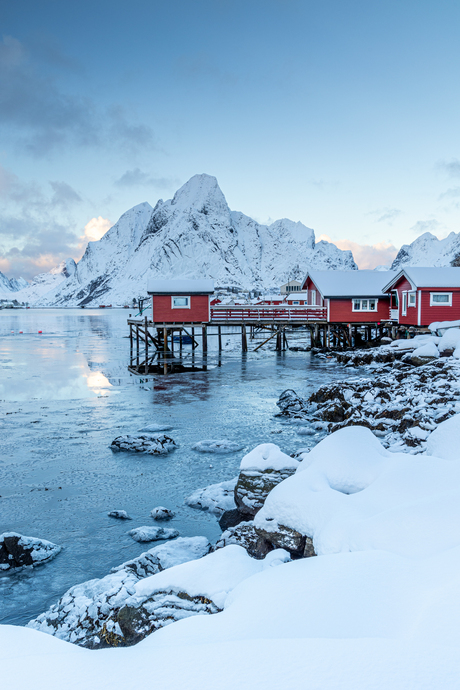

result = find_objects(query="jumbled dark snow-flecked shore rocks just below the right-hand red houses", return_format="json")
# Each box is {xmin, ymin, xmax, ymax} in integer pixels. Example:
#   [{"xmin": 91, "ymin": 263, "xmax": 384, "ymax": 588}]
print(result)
[{"xmin": 278, "ymin": 358, "xmax": 460, "ymax": 453}]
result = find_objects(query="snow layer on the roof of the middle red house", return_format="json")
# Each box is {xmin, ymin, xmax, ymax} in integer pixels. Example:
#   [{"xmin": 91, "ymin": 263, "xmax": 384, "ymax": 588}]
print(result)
[{"xmin": 305, "ymin": 271, "xmax": 395, "ymax": 297}]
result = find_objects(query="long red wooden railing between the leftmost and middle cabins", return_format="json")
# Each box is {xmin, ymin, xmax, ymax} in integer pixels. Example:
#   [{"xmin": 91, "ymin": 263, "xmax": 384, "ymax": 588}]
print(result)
[{"xmin": 211, "ymin": 304, "xmax": 327, "ymax": 323}]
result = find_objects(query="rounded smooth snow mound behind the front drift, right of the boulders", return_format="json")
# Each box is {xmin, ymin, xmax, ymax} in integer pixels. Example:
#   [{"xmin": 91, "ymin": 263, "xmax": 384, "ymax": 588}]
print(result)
[{"xmin": 254, "ymin": 427, "xmax": 460, "ymax": 558}]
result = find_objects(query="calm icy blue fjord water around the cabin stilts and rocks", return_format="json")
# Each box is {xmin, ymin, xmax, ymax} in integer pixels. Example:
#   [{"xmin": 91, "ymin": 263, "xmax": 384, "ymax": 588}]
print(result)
[{"xmin": 0, "ymin": 309, "xmax": 345, "ymax": 625}]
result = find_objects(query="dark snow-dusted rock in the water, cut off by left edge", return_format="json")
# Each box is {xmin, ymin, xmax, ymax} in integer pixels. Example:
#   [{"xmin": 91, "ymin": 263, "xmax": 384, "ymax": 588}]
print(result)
[{"xmin": 0, "ymin": 532, "xmax": 61, "ymax": 571}]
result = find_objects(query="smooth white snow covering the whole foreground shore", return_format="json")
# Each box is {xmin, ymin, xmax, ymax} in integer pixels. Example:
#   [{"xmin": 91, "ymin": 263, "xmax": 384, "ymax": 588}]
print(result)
[{"xmin": 0, "ymin": 416, "xmax": 460, "ymax": 690}]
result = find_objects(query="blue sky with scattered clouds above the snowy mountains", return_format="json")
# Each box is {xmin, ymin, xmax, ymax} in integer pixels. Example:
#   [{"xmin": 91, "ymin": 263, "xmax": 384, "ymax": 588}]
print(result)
[{"xmin": 0, "ymin": 0, "xmax": 460, "ymax": 279}]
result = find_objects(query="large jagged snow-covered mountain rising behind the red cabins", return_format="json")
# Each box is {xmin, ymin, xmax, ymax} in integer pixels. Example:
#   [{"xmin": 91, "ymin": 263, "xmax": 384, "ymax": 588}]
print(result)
[{"xmin": 21, "ymin": 175, "xmax": 357, "ymax": 306}]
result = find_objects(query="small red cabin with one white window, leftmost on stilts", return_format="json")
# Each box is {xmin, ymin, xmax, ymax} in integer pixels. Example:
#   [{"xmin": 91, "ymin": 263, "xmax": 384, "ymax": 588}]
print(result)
[{"xmin": 147, "ymin": 279, "xmax": 214, "ymax": 324}]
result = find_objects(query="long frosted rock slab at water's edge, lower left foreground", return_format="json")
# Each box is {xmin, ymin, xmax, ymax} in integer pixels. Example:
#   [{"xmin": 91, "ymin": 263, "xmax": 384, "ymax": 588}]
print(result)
[{"xmin": 28, "ymin": 537, "xmax": 211, "ymax": 649}]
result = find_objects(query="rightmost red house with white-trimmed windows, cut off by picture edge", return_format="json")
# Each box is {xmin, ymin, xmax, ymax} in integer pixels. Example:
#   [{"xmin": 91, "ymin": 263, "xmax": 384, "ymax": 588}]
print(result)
[{"xmin": 383, "ymin": 267, "xmax": 460, "ymax": 326}]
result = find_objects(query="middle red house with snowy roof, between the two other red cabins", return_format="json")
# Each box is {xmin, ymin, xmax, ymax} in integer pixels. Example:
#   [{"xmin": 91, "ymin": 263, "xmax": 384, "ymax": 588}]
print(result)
[{"xmin": 295, "ymin": 270, "xmax": 394, "ymax": 324}]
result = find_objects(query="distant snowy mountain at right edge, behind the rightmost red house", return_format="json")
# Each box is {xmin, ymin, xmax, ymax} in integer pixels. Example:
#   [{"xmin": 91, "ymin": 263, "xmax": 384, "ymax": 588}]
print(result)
[{"xmin": 391, "ymin": 232, "xmax": 460, "ymax": 271}]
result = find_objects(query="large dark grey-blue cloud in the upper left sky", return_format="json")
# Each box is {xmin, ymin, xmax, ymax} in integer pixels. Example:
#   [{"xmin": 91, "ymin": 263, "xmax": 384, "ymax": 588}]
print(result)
[{"xmin": 0, "ymin": 36, "xmax": 154, "ymax": 157}]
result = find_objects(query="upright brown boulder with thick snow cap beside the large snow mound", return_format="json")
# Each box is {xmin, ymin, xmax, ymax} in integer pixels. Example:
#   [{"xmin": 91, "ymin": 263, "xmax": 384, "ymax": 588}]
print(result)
[{"xmin": 235, "ymin": 443, "xmax": 299, "ymax": 517}]
